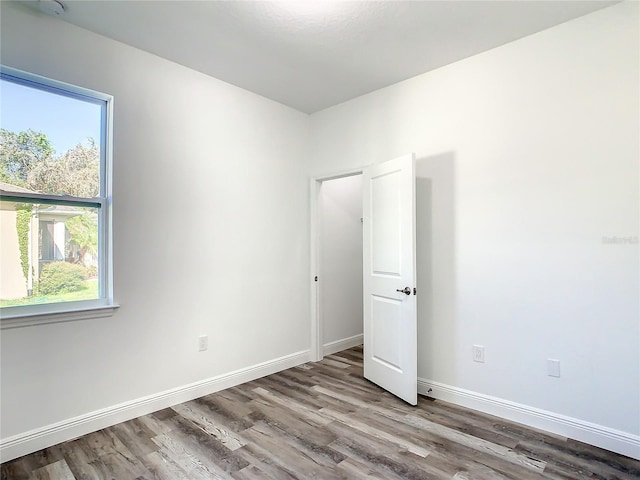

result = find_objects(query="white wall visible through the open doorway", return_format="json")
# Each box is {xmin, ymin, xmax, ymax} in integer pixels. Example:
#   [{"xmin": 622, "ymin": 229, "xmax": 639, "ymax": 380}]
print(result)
[{"xmin": 318, "ymin": 175, "xmax": 363, "ymax": 351}]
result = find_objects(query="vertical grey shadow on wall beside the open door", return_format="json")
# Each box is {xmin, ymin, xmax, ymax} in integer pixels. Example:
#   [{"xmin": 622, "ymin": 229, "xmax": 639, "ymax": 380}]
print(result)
[{"xmin": 416, "ymin": 152, "xmax": 457, "ymax": 384}]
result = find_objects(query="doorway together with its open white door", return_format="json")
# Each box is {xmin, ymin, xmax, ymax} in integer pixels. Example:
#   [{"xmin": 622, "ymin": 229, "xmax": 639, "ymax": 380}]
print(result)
[{"xmin": 310, "ymin": 153, "xmax": 417, "ymax": 405}]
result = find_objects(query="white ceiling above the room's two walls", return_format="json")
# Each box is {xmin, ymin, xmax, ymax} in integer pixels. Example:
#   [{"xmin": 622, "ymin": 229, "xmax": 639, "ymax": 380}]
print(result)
[{"xmin": 28, "ymin": 0, "xmax": 616, "ymax": 113}]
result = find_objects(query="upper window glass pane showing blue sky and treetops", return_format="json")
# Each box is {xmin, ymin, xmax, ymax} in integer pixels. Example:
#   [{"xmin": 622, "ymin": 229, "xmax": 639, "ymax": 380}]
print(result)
[{"xmin": 0, "ymin": 79, "xmax": 103, "ymax": 197}]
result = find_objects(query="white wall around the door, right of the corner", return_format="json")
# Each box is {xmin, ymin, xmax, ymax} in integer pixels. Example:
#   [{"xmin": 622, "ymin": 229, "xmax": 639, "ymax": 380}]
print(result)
[{"xmin": 311, "ymin": 2, "xmax": 640, "ymax": 455}]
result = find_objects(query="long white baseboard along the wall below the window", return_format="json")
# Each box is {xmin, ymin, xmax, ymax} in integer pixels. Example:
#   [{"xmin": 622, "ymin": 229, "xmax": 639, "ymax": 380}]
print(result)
[{"xmin": 0, "ymin": 350, "xmax": 309, "ymax": 463}]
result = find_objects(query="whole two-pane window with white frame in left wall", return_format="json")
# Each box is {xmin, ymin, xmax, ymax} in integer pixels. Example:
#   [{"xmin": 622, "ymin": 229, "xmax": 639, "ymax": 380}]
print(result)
[{"xmin": 0, "ymin": 67, "xmax": 113, "ymax": 328}]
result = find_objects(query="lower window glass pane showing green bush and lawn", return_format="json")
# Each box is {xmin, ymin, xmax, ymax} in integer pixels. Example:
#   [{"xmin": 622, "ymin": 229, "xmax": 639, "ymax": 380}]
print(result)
[{"xmin": 0, "ymin": 200, "xmax": 100, "ymax": 307}]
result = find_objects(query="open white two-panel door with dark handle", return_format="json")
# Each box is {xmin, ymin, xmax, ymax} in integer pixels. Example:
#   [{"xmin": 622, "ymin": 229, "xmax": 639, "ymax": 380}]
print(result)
[{"xmin": 362, "ymin": 154, "xmax": 418, "ymax": 405}]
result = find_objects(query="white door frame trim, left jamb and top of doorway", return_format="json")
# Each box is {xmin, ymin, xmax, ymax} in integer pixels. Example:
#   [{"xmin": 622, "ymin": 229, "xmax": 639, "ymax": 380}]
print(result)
[{"xmin": 309, "ymin": 167, "xmax": 366, "ymax": 362}]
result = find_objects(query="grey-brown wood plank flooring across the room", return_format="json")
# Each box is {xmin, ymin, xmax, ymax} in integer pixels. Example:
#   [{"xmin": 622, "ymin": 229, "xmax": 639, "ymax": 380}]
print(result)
[{"xmin": 0, "ymin": 347, "xmax": 640, "ymax": 480}]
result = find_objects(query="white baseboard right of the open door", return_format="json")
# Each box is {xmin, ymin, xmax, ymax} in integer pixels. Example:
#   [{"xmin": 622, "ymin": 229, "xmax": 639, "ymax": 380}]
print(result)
[{"xmin": 418, "ymin": 378, "xmax": 640, "ymax": 460}]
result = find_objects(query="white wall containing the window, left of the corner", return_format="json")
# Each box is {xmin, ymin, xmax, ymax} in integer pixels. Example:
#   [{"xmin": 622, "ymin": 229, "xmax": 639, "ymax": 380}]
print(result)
[{"xmin": 0, "ymin": 2, "xmax": 310, "ymax": 458}]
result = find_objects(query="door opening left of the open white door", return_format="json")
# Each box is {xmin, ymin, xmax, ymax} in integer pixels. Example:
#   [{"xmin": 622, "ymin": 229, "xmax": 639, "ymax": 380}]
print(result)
[{"xmin": 311, "ymin": 171, "xmax": 363, "ymax": 361}]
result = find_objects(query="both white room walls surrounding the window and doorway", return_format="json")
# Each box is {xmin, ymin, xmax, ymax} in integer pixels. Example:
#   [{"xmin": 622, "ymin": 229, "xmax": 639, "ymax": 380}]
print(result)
[{"xmin": 0, "ymin": 2, "xmax": 640, "ymax": 462}]
